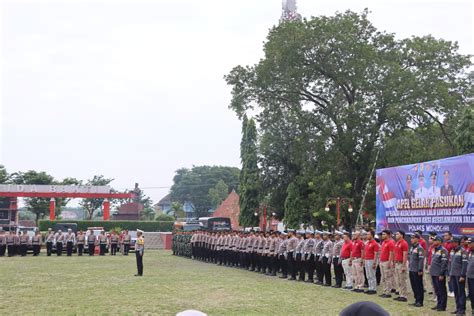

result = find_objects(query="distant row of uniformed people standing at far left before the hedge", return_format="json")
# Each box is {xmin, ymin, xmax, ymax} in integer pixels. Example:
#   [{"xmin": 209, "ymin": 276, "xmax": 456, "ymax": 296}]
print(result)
[{"xmin": 0, "ymin": 229, "xmax": 133, "ymax": 257}]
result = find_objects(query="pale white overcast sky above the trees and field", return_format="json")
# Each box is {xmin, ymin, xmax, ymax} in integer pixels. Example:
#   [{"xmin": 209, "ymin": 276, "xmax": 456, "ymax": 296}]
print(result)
[{"xmin": 0, "ymin": 0, "xmax": 474, "ymax": 202}]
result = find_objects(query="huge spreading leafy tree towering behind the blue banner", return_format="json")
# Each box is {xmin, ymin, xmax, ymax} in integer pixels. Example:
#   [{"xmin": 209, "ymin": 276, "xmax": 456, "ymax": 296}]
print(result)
[{"xmin": 226, "ymin": 11, "xmax": 472, "ymax": 227}]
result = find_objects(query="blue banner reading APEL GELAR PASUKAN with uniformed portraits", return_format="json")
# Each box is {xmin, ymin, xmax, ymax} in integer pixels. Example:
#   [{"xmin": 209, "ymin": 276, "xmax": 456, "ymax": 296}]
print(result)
[{"xmin": 376, "ymin": 154, "xmax": 474, "ymax": 235}]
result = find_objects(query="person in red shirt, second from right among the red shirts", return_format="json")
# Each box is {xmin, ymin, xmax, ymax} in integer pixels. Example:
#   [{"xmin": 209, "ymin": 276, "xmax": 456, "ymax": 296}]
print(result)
[{"xmin": 380, "ymin": 229, "xmax": 395, "ymax": 298}]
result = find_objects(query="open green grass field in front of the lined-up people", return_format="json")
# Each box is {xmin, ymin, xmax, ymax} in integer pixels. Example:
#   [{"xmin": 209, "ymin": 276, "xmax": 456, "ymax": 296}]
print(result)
[{"xmin": 0, "ymin": 251, "xmax": 462, "ymax": 315}]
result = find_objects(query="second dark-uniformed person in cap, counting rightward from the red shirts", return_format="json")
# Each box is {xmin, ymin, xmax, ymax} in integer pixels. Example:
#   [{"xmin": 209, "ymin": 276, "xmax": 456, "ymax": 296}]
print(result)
[{"xmin": 430, "ymin": 236, "xmax": 448, "ymax": 312}]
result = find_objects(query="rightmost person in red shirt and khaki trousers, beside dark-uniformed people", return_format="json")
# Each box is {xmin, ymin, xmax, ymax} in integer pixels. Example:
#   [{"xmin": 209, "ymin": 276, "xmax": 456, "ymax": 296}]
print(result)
[{"xmin": 393, "ymin": 230, "xmax": 408, "ymax": 302}]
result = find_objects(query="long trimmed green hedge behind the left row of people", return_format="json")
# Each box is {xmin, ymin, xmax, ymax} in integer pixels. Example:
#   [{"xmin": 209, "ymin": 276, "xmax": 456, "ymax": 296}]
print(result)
[{"xmin": 38, "ymin": 219, "xmax": 174, "ymax": 232}]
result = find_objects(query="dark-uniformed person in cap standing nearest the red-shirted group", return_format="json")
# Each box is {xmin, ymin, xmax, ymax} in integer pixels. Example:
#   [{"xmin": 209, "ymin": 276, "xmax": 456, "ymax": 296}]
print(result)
[{"xmin": 408, "ymin": 233, "xmax": 425, "ymax": 307}]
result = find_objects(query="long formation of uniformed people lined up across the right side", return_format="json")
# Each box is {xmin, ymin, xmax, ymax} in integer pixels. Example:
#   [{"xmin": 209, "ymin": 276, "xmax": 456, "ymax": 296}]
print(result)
[{"xmin": 173, "ymin": 230, "xmax": 474, "ymax": 315}]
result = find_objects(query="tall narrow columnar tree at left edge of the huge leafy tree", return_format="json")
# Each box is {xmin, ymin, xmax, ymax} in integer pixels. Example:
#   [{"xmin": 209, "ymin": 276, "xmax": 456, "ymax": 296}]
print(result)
[{"xmin": 239, "ymin": 119, "xmax": 260, "ymax": 227}]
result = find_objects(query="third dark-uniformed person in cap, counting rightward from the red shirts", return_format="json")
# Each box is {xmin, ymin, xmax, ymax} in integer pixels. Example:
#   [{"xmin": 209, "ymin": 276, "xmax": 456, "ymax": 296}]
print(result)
[{"xmin": 448, "ymin": 237, "xmax": 468, "ymax": 315}]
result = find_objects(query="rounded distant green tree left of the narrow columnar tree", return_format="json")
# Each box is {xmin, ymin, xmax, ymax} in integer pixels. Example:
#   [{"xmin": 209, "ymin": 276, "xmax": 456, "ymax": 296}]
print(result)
[{"xmin": 170, "ymin": 166, "xmax": 240, "ymax": 217}]
